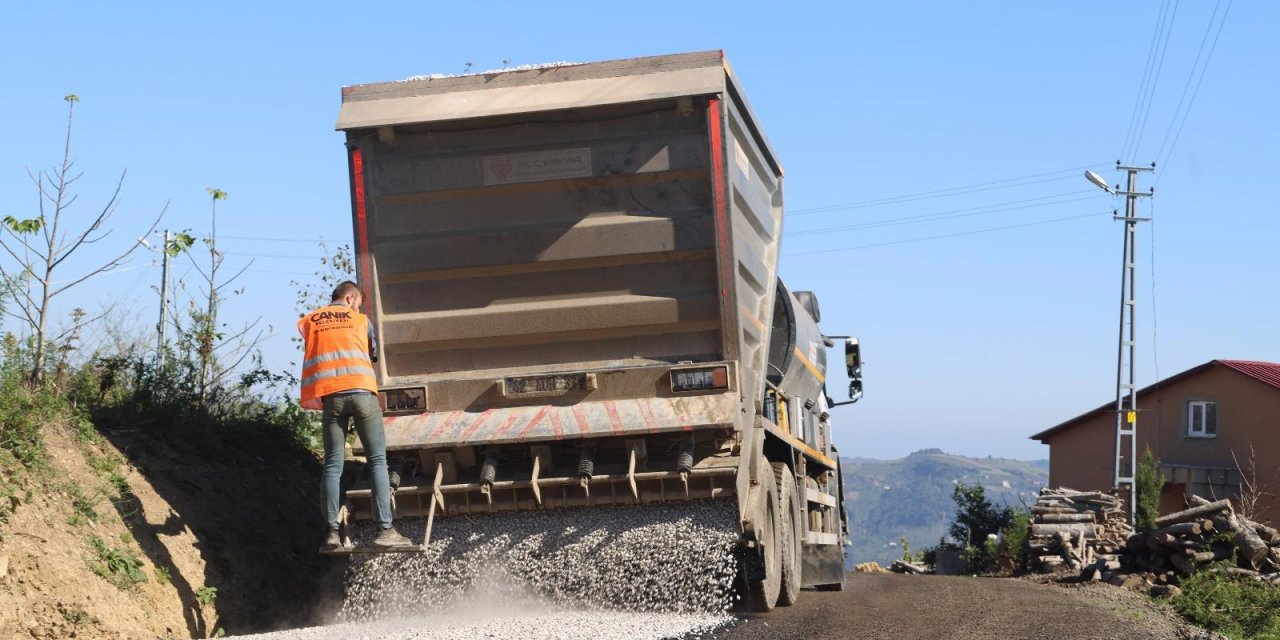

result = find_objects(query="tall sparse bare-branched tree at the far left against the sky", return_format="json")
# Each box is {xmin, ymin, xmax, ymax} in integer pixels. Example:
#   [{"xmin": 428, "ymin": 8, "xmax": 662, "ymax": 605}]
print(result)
[{"xmin": 0, "ymin": 93, "xmax": 168, "ymax": 384}]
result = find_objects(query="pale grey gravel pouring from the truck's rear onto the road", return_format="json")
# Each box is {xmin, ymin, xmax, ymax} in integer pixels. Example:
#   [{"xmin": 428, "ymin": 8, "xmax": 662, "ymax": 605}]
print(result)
[{"xmin": 230, "ymin": 500, "xmax": 739, "ymax": 640}]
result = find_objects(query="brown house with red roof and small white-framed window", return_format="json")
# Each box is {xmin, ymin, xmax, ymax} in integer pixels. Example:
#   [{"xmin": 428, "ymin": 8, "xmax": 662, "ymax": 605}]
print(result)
[{"xmin": 1032, "ymin": 360, "xmax": 1280, "ymax": 522}]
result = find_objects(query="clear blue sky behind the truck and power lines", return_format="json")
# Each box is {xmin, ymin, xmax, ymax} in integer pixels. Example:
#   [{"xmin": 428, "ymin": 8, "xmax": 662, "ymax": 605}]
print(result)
[{"xmin": 0, "ymin": 0, "xmax": 1280, "ymax": 457}]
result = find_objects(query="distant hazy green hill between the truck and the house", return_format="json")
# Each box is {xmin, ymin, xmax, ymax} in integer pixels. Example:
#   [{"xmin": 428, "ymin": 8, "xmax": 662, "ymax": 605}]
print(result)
[{"xmin": 841, "ymin": 449, "xmax": 1048, "ymax": 566}]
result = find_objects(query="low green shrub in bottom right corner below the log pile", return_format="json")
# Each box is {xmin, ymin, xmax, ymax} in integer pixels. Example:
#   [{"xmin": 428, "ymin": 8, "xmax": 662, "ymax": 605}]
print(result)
[{"xmin": 1174, "ymin": 571, "xmax": 1280, "ymax": 640}]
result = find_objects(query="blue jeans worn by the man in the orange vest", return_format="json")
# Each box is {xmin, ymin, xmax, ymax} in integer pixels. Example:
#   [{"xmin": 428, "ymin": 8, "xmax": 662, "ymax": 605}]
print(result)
[{"xmin": 320, "ymin": 392, "xmax": 392, "ymax": 529}]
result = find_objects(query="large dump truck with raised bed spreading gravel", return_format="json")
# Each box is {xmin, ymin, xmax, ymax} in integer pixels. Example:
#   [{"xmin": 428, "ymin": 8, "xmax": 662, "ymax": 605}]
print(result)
[{"xmin": 337, "ymin": 51, "xmax": 861, "ymax": 611}]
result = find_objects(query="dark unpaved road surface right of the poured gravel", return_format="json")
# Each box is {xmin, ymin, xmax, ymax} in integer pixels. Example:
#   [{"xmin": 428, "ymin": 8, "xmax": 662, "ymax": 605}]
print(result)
[{"xmin": 713, "ymin": 573, "xmax": 1196, "ymax": 640}]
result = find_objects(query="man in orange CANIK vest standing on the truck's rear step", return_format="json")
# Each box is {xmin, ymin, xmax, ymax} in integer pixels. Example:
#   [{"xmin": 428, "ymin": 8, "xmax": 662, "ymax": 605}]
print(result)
[{"xmin": 298, "ymin": 280, "xmax": 412, "ymax": 549}]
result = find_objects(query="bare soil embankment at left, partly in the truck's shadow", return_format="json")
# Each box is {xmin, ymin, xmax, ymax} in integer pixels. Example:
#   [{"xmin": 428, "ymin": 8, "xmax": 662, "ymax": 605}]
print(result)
[{"xmin": 0, "ymin": 425, "xmax": 342, "ymax": 640}]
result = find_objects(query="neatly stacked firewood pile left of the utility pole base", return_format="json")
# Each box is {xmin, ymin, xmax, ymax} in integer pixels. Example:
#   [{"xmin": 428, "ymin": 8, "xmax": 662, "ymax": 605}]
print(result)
[{"xmin": 1028, "ymin": 488, "xmax": 1133, "ymax": 573}]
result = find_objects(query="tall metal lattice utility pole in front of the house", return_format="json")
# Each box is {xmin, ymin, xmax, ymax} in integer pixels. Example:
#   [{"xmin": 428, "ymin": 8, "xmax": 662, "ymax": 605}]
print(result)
[{"xmin": 1107, "ymin": 160, "xmax": 1156, "ymax": 525}]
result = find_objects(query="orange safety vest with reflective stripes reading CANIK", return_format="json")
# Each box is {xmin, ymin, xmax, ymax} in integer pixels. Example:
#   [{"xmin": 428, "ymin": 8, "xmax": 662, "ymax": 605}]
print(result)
[{"xmin": 298, "ymin": 305, "xmax": 378, "ymax": 410}]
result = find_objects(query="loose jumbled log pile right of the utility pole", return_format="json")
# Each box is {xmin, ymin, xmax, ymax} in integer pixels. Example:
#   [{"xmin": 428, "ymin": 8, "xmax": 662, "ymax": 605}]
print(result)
[{"xmin": 1125, "ymin": 497, "xmax": 1280, "ymax": 584}]
